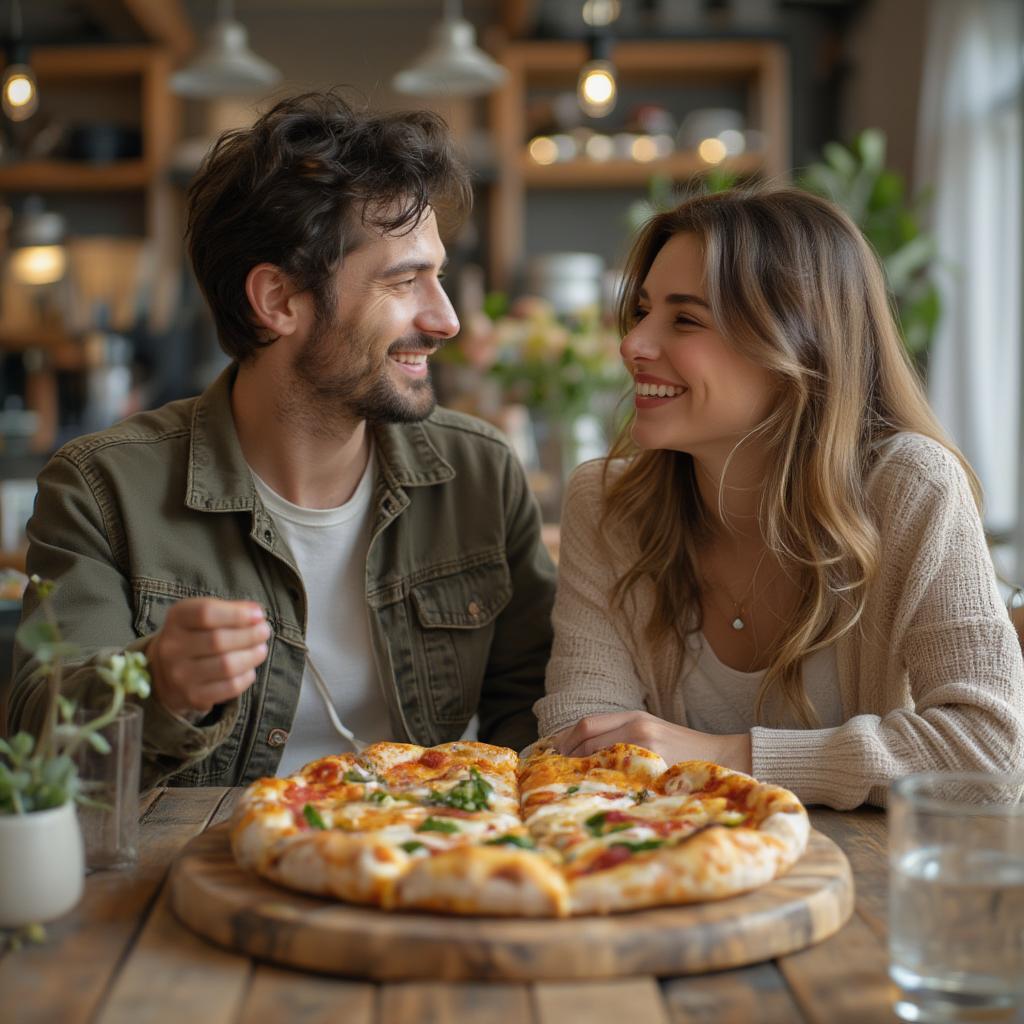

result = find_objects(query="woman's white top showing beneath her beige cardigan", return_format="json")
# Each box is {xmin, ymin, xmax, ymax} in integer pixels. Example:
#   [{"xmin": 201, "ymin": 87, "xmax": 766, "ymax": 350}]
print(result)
[{"xmin": 680, "ymin": 633, "xmax": 843, "ymax": 736}]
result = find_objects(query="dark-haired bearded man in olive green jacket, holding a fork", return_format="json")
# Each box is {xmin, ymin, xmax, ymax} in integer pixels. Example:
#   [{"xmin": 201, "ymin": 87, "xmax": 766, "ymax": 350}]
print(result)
[{"xmin": 10, "ymin": 93, "xmax": 554, "ymax": 785}]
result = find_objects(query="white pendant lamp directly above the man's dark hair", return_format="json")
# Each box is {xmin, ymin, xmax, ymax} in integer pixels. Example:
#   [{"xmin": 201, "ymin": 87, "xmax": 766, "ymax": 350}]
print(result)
[{"xmin": 171, "ymin": 0, "xmax": 282, "ymax": 99}]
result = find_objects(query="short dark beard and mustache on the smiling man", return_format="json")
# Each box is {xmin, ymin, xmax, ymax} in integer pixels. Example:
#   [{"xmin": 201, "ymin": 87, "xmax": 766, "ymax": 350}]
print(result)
[{"xmin": 293, "ymin": 307, "xmax": 438, "ymax": 432}]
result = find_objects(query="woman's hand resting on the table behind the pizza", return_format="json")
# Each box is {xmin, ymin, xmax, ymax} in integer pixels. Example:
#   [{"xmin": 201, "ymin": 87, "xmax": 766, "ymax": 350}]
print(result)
[{"xmin": 550, "ymin": 711, "xmax": 752, "ymax": 774}]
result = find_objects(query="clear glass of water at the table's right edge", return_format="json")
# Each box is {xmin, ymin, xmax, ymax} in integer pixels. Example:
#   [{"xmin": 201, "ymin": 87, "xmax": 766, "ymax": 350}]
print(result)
[{"xmin": 889, "ymin": 772, "xmax": 1024, "ymax": 1021}]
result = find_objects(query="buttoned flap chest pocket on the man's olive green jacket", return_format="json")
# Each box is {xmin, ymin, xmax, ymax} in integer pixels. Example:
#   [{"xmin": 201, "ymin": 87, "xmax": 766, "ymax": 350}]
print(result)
[{"xmin": 410, "ymin": 561, "xmax": 512, "ymax": 729}]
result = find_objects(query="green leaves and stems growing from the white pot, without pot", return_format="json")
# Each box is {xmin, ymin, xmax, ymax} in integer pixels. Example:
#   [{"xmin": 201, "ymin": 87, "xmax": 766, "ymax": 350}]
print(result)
[{"xmin": 0, "ymin": 575, "xmax": 150, "ymax": 815}]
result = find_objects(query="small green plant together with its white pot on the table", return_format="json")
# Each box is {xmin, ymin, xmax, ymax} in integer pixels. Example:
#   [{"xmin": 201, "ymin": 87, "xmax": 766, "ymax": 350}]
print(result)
[{"xmin": 0, "ymin": 577, "xmax": 150, "ymax": 928}]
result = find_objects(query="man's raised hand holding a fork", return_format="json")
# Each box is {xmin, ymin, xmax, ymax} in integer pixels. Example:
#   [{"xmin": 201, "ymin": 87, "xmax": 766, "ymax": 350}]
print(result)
[{"xmin": 145, "ymin": 597, "xmax": 270, "ymax": 717}]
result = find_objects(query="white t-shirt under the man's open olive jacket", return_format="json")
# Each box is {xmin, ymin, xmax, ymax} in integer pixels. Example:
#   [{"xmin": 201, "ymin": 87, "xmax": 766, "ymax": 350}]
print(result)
[{"xmin": 247, "ymin": 454, "xmax": 393, "ymax": 775}]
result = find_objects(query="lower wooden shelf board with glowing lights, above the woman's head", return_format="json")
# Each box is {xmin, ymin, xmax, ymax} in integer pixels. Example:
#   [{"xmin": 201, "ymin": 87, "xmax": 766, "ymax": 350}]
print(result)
[{"xmin": 522, "ymin": 153, "xmax": 765, "ymax": 188}]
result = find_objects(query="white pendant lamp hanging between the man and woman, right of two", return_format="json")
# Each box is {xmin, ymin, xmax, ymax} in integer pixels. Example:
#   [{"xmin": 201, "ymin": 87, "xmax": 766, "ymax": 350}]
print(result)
[{"xmin": 391, "ymin": 0, "xmax": 508, "ymax": 96}]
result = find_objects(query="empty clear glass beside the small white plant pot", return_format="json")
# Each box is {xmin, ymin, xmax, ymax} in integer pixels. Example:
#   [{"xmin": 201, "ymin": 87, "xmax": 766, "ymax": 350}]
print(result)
[{"xmin": 75, "ymin": 705, "xmax": 142, "ymax": 870}]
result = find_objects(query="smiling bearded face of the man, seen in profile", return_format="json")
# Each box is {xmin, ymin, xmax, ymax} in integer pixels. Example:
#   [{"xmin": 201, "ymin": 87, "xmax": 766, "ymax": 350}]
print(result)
[{"xmin": 294, "ymin": 210, "xmax": 459, "ymax": 428}]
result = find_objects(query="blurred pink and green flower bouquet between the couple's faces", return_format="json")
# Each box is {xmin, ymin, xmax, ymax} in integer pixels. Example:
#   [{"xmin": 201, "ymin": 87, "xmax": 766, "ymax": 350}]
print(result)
[{"xmin": 459, "ymin": 293, "xmax": 626, "ymax": 421}]
